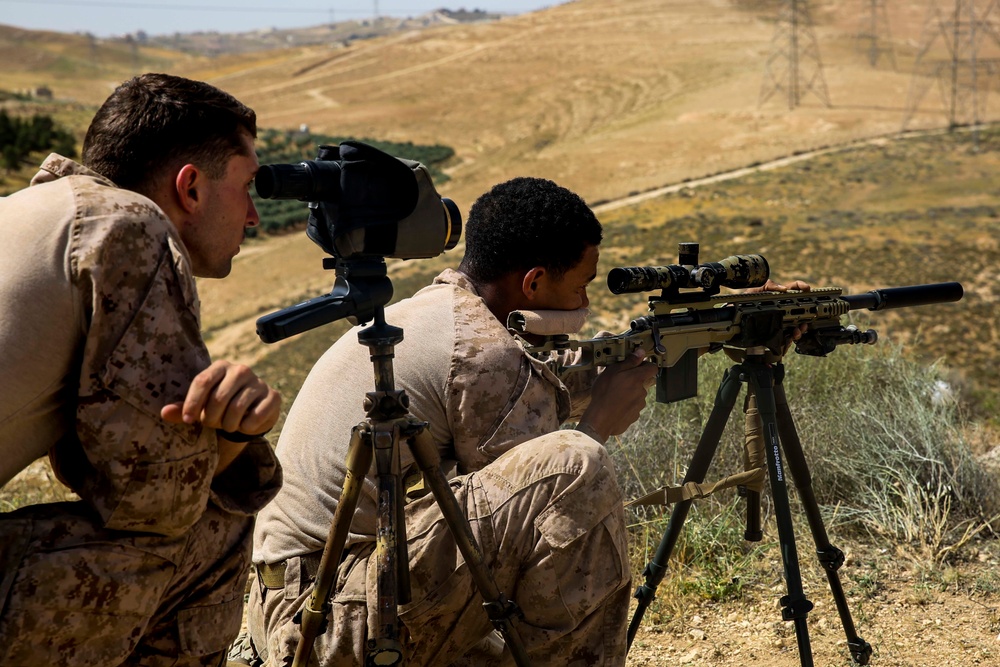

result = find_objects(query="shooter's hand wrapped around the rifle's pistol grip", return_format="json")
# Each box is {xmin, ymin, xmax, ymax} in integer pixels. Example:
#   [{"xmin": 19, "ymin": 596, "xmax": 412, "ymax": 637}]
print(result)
[{"xmin": 580, "ymin": 348, "xmax": 658, "ymax": 440}]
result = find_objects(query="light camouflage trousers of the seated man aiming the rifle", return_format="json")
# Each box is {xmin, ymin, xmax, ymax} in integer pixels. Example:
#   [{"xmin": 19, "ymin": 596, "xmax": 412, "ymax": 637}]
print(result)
[{"xmin": 247, "ymin": 431, "xmax": 630, "ymax": 667}]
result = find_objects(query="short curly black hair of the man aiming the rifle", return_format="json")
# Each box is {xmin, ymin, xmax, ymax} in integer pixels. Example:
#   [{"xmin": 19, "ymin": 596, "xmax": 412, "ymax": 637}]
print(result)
[{"xmin": 460, "ymin": 177, "xmax": 603, "ymax": 283}]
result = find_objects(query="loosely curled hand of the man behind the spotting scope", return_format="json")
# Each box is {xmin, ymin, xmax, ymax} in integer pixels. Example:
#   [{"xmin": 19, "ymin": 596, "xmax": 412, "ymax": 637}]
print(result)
[{"xmin": 160, "ymin": 361, "xmax": 281, "ymax": 444}]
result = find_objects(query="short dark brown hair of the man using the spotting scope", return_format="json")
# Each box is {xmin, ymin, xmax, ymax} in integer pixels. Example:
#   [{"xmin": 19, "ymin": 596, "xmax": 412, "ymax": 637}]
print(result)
[{"xmin": 83, "ymin": 73, "xmax": 257, "ymax": 194}]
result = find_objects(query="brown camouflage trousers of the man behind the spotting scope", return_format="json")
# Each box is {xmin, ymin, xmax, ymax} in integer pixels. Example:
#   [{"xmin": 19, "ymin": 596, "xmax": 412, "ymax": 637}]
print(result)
[{"xmin": 0, "ymin": 502, "xmax": 252, "ymax": 667}]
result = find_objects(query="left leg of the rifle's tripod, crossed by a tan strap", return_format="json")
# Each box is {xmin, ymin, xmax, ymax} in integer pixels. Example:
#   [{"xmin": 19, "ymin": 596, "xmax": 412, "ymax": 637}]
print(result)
[{"xmin": 628, "ymin": 369, "xmax": 742, "ymax": 648}]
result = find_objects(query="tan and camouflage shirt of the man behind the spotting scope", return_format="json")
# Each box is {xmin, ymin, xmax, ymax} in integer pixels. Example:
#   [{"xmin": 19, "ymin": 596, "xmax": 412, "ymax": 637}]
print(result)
[{"xmin": 0, "ymin": 154, "xmax": 281, "ymax": 536}]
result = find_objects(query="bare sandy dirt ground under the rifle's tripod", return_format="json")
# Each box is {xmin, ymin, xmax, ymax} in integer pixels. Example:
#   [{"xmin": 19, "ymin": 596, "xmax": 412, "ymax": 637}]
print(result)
[{"xmin": 627, "ymin": 545, "xmax": 1000, "ymax": 667}]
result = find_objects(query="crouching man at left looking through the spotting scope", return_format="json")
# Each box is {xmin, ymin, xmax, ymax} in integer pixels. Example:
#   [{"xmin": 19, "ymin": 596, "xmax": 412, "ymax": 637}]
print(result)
[{"xmin": 0, "ymin": 74, "xmax": 281, "ymax": 667}]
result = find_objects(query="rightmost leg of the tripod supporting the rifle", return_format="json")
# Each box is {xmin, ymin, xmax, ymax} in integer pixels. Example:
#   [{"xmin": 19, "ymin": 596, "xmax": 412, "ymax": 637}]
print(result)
[{"xmin": 774, "ymin": 366, "xmax": 872, "ymax": 665}]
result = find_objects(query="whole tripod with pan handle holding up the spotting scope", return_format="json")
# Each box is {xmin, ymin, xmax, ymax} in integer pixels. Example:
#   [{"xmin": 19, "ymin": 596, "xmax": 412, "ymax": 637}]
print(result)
[{"xmin": 258, "ymin": 261, "xmax": 530, "ymax": 667}]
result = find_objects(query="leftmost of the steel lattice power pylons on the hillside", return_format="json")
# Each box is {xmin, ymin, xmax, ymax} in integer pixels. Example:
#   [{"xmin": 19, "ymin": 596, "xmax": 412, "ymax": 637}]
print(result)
[{"xmin": 758, "ymin": 0, "xmax": 830, "ymax": 109}]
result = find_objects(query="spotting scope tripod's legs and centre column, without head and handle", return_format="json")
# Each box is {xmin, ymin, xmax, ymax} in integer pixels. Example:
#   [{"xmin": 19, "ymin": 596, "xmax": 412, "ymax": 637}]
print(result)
[{"xmin": 292, "ymin": 306, "xmax": 531, "ymax": 667}]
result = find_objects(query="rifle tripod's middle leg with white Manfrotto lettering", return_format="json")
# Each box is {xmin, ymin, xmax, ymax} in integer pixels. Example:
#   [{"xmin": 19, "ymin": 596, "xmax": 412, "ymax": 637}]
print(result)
[{"xmin": 743, "ymin": 356, "xmax": 813, "ymax": 667}]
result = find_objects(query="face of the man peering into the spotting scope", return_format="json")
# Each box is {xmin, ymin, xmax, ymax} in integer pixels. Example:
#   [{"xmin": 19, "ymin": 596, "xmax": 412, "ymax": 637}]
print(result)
[{"xmin": 184, "ymin": 133, "xmax": 260, "ymax": 278}]
